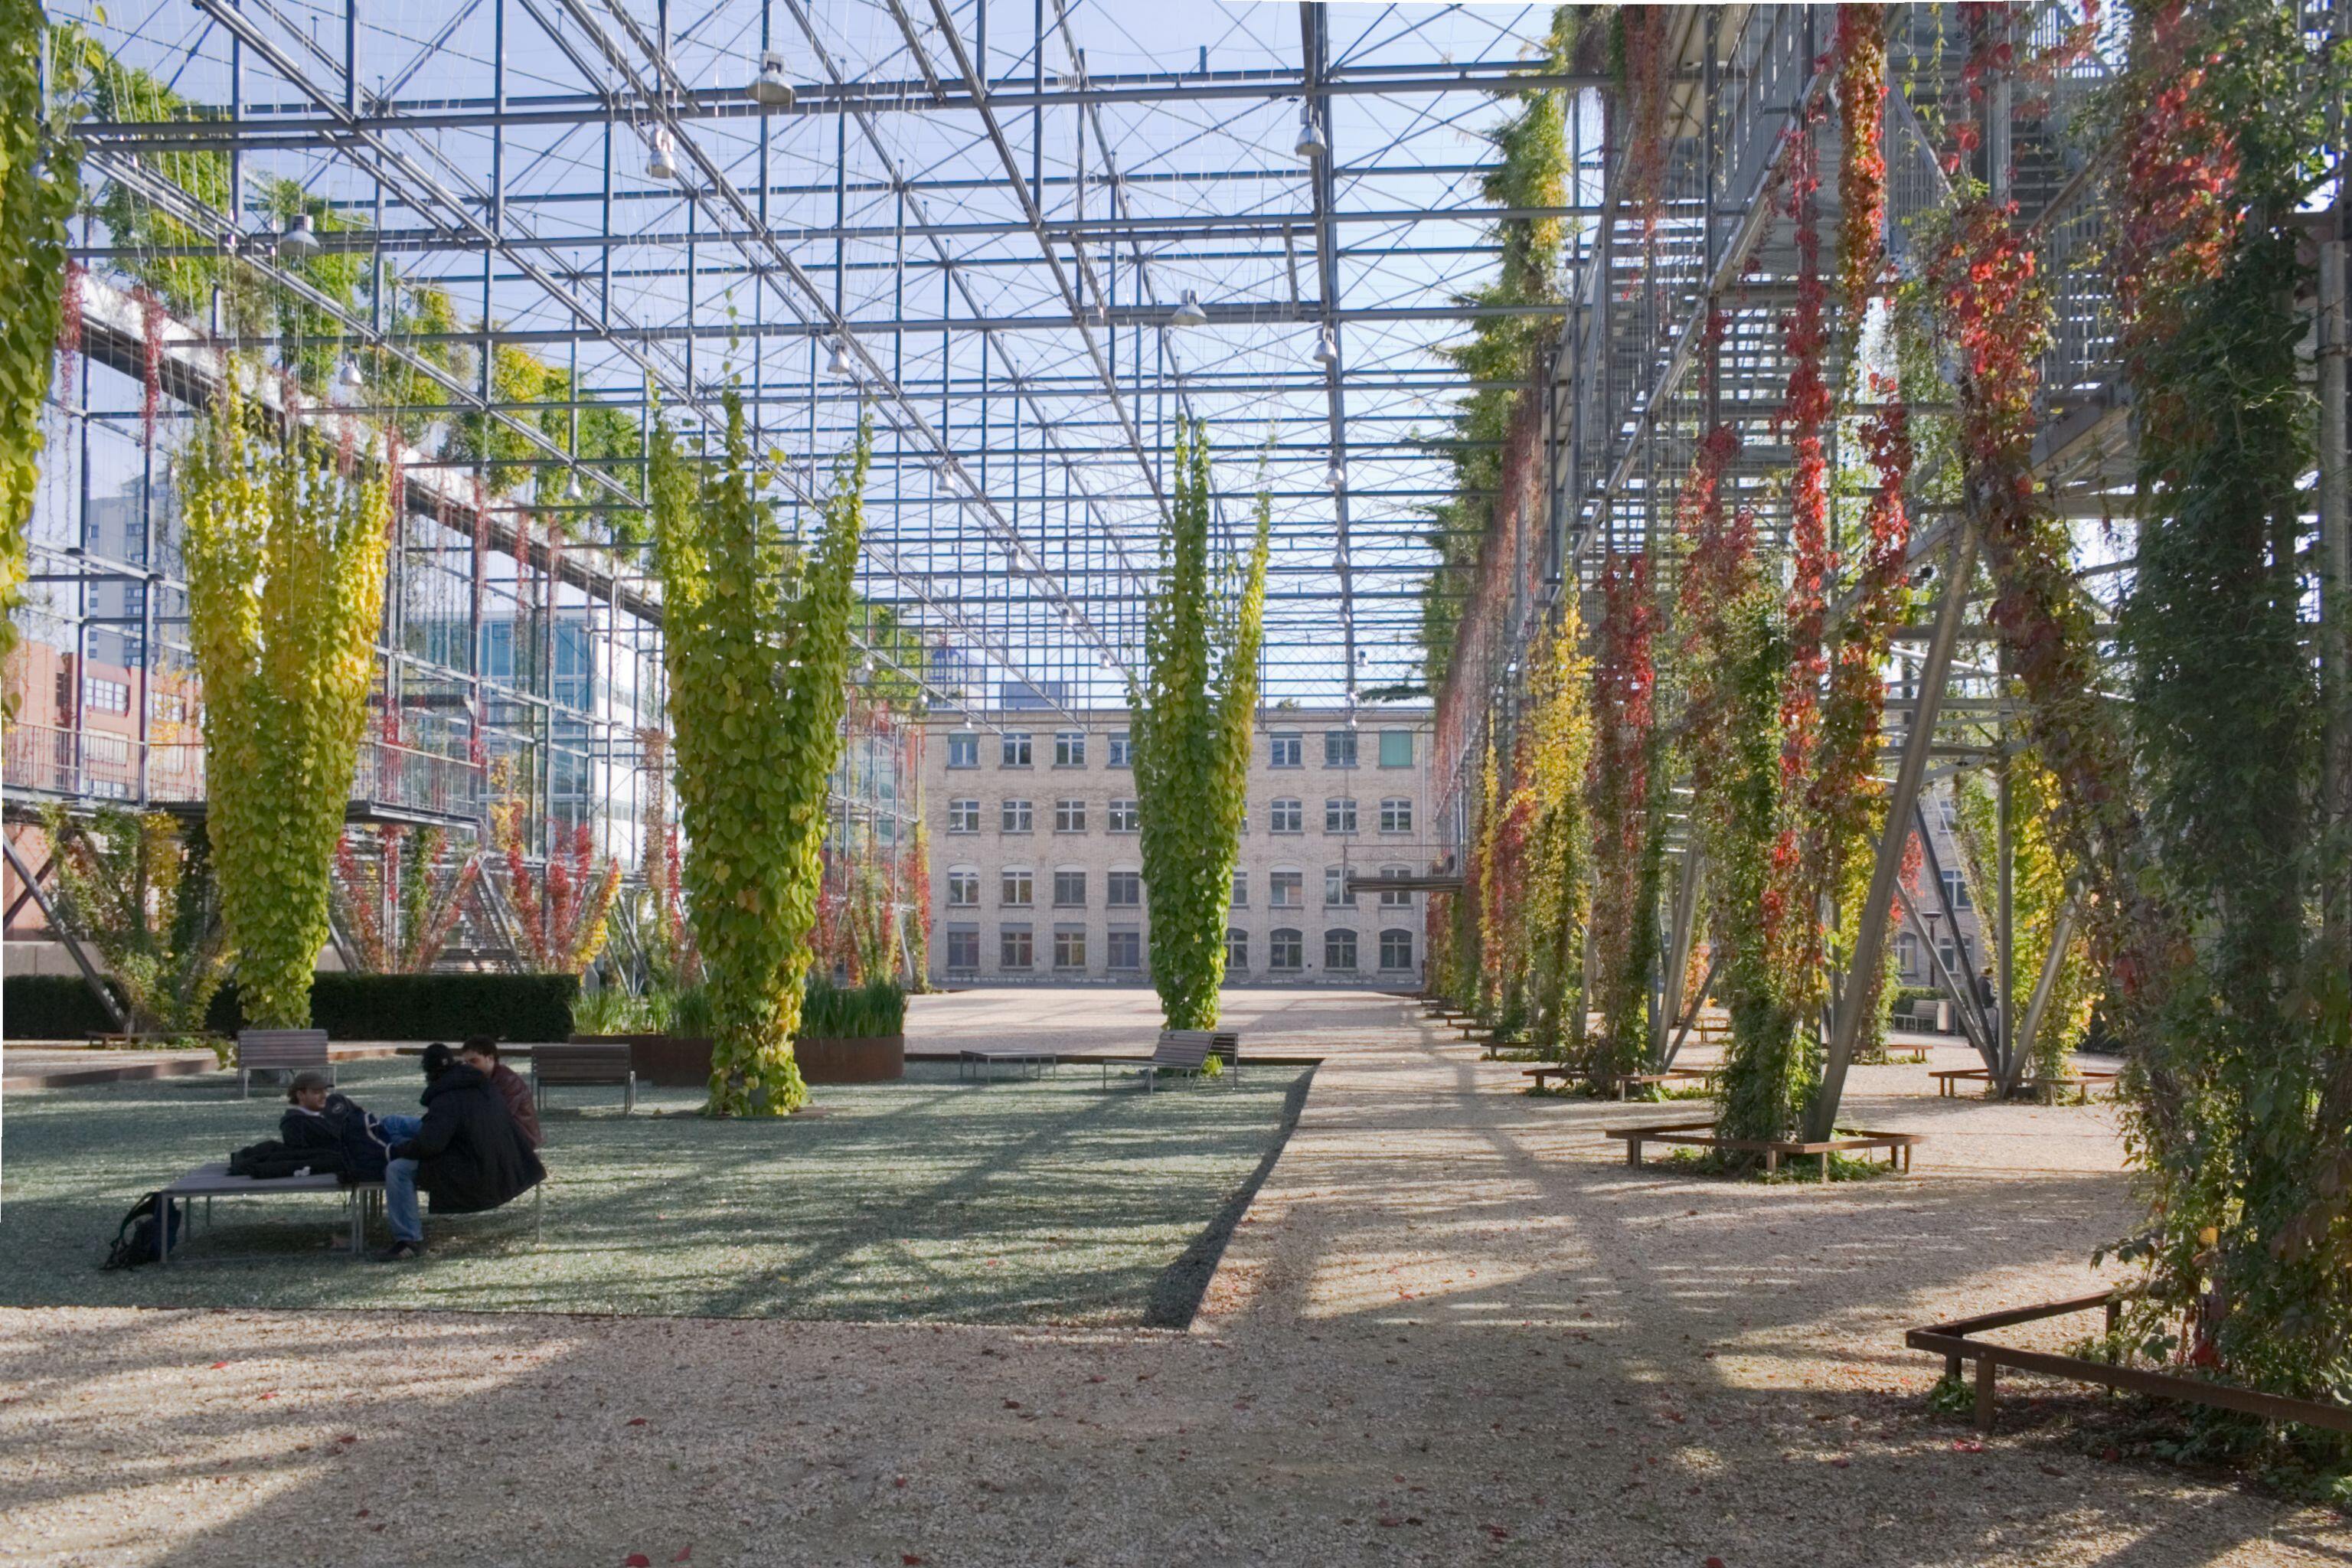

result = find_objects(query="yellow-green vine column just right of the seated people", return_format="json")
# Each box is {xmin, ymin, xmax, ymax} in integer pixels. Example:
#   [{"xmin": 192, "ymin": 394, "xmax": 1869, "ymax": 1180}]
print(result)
[{"xmin": 652, "ymin": 393, "xmax": 873, "ymax": 1116}]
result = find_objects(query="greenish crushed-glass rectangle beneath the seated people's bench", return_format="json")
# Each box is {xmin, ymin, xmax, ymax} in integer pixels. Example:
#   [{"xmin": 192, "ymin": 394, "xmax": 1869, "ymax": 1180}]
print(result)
[{"xmin": 0, "ymin": 1060, "xmax": 1305, "ymax": 1326}]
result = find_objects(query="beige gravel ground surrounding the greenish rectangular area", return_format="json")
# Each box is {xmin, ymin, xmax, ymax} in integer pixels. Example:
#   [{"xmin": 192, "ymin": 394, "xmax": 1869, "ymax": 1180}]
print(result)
[{"xmin": 0, "ymin": 990, "xmax": 2352, "ymax": 1568}]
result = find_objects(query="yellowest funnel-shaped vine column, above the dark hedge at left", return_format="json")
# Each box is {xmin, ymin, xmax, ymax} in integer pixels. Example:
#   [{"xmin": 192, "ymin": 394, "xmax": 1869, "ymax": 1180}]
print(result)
[{"xmin": 174, "ymin": 376, "xmax": 390, "ymax": 1030}]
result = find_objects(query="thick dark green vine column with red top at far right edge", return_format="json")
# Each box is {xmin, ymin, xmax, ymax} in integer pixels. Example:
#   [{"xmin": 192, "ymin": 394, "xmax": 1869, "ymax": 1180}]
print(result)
[{"xmin": 2110, "ymin": 0, "xmax": 2352, "ymax": 1439}]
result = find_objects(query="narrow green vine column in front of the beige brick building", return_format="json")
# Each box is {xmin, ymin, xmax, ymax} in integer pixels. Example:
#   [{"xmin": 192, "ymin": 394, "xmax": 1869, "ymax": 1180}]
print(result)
[{"xmin": 1126, "ymin": 423, "xmax": 1272, "ymax": 1030}]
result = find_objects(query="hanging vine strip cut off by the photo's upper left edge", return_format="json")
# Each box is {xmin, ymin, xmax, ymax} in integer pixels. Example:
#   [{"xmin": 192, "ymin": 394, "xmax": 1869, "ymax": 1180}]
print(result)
[{"xmin": 0, "ymin": 0, "xmax": 80, "ymax": 705}]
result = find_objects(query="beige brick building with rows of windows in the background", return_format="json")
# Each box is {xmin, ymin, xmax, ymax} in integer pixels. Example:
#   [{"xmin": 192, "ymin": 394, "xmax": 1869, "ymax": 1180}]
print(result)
[{"xmin": 922, "ymin": 707, "xmax": 1439, "ymax": 988}]
